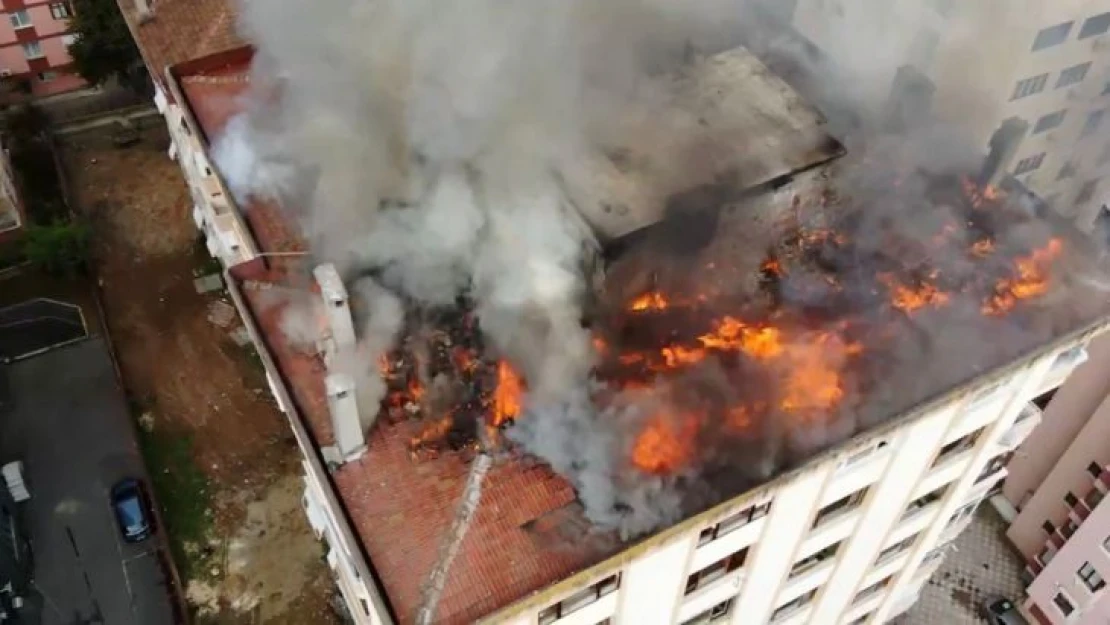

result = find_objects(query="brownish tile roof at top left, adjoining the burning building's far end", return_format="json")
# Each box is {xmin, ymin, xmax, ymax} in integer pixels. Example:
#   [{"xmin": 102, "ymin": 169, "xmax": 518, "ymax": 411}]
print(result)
[{"xmin": 119, "ymin": 0, "xmax": 243, "ymax": 86}]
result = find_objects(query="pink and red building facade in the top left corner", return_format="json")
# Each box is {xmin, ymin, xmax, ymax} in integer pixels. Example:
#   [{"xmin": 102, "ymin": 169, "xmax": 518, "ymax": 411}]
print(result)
[{"xmin": 0, "ymin": 0, "xmax": 85, "ymax": 97}]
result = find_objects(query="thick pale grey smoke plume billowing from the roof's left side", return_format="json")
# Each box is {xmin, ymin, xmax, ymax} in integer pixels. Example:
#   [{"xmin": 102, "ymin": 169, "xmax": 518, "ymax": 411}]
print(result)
[{"xmin": 214, "ymin": 0, "xmax": 754, "ymax": 530}]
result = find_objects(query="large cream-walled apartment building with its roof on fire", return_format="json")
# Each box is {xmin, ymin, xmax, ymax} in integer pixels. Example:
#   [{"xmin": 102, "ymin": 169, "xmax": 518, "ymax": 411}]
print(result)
[{"xmin": 152, "ymin": 15, "xmax": 1110, "ymax": 625}]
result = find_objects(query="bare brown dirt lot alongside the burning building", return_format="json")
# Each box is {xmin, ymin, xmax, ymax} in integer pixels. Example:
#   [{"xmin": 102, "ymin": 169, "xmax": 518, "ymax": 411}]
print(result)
[{"xmin": 62, "ymin": 130, "xmax": 337, "ymax": 625}]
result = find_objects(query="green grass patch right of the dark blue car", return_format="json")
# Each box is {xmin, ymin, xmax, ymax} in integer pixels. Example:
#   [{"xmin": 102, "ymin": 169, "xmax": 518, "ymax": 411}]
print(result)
[{"xmin": 139, "ymin": 427, "xmax": 211, "ymax": 579}]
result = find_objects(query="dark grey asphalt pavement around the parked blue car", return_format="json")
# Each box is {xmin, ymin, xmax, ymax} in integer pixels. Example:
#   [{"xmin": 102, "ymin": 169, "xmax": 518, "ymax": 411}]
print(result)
[{"xmin": 0, "ymin": 339, "xmax": 173, "ymax": 625}]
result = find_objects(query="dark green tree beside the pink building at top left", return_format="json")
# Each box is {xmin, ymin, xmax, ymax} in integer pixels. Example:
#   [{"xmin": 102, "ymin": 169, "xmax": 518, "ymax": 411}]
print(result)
[{"xmin": 69, "ymin": 0, "xmax": 145, "ymax": 89}]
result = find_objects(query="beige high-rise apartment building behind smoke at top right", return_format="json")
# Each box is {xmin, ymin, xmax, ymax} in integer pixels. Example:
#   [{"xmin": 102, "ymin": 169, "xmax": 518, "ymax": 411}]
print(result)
[{"xmin": 777, "ymin": 0, "xmax": 1110, "ymax": 230}]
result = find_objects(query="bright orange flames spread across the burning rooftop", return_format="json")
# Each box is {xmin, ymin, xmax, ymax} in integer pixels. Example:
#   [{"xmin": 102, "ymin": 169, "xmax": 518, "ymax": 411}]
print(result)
[{"xmin": 388, "ymin": 180, "xmax": 1063, "ymax": 476}]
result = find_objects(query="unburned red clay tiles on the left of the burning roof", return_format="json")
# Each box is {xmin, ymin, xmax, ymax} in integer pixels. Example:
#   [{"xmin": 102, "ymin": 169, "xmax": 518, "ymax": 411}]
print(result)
[{"xmin": 179, "ymin": 56, "xmax": 619, "ymax": 625}]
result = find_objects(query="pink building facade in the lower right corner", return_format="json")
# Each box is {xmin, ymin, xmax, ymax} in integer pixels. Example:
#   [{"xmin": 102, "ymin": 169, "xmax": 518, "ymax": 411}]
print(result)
[{"xmin": 1002, "ymin": 337, "xmax": 1110, "ymax": 625}]
